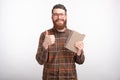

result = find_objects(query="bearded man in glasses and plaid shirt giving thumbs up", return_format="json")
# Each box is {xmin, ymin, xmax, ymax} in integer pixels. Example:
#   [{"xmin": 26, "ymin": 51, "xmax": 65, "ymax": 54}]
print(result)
[{"xmin": 36, "ymin": 4, "xmax": 85, "ymax": 80}]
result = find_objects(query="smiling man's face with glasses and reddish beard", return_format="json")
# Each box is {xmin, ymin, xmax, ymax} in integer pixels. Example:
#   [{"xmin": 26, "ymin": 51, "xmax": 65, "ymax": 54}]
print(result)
[{"xmin": 52, "ymin": 8, "xmax": 67, "ymax": 30}]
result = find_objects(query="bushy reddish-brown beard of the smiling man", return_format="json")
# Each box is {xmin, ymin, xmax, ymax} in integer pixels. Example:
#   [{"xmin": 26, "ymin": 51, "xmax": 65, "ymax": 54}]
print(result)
[{"xmin": 53, "ymin": 19, "xmax": 67, "ymax": 30}]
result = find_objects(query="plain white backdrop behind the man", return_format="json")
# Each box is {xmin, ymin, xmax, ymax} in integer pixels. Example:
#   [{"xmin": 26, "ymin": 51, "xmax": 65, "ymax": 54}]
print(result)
[{"xmin": 0, "ymin": 0, "xmax": 120, "ymax": 80}]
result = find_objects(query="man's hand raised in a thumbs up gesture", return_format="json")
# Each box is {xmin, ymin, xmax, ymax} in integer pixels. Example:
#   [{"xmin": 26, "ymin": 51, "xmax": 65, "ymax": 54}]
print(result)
[{"xmin": 43, "ymin": 31, "xmax": 55, "ymax": 49}]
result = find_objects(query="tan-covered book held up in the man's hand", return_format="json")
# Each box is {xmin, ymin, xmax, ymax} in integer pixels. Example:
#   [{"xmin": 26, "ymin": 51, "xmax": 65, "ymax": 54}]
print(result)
[{"xmin": 64, "ymin": 31, "xmax": 85, "ymax": 53}]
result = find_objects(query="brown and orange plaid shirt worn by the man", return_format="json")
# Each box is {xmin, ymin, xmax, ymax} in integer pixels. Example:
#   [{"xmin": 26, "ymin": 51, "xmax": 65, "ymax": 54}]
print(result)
[{"xmin": 36, "ymin": 28, "xmax": 85, "ymax": 80}]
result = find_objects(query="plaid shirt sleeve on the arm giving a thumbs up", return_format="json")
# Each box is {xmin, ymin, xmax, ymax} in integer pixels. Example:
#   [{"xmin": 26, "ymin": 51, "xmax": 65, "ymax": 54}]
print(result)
[{"xmin": 36, "ymin": 33, "xmax": 48, "ymax": 65}]
